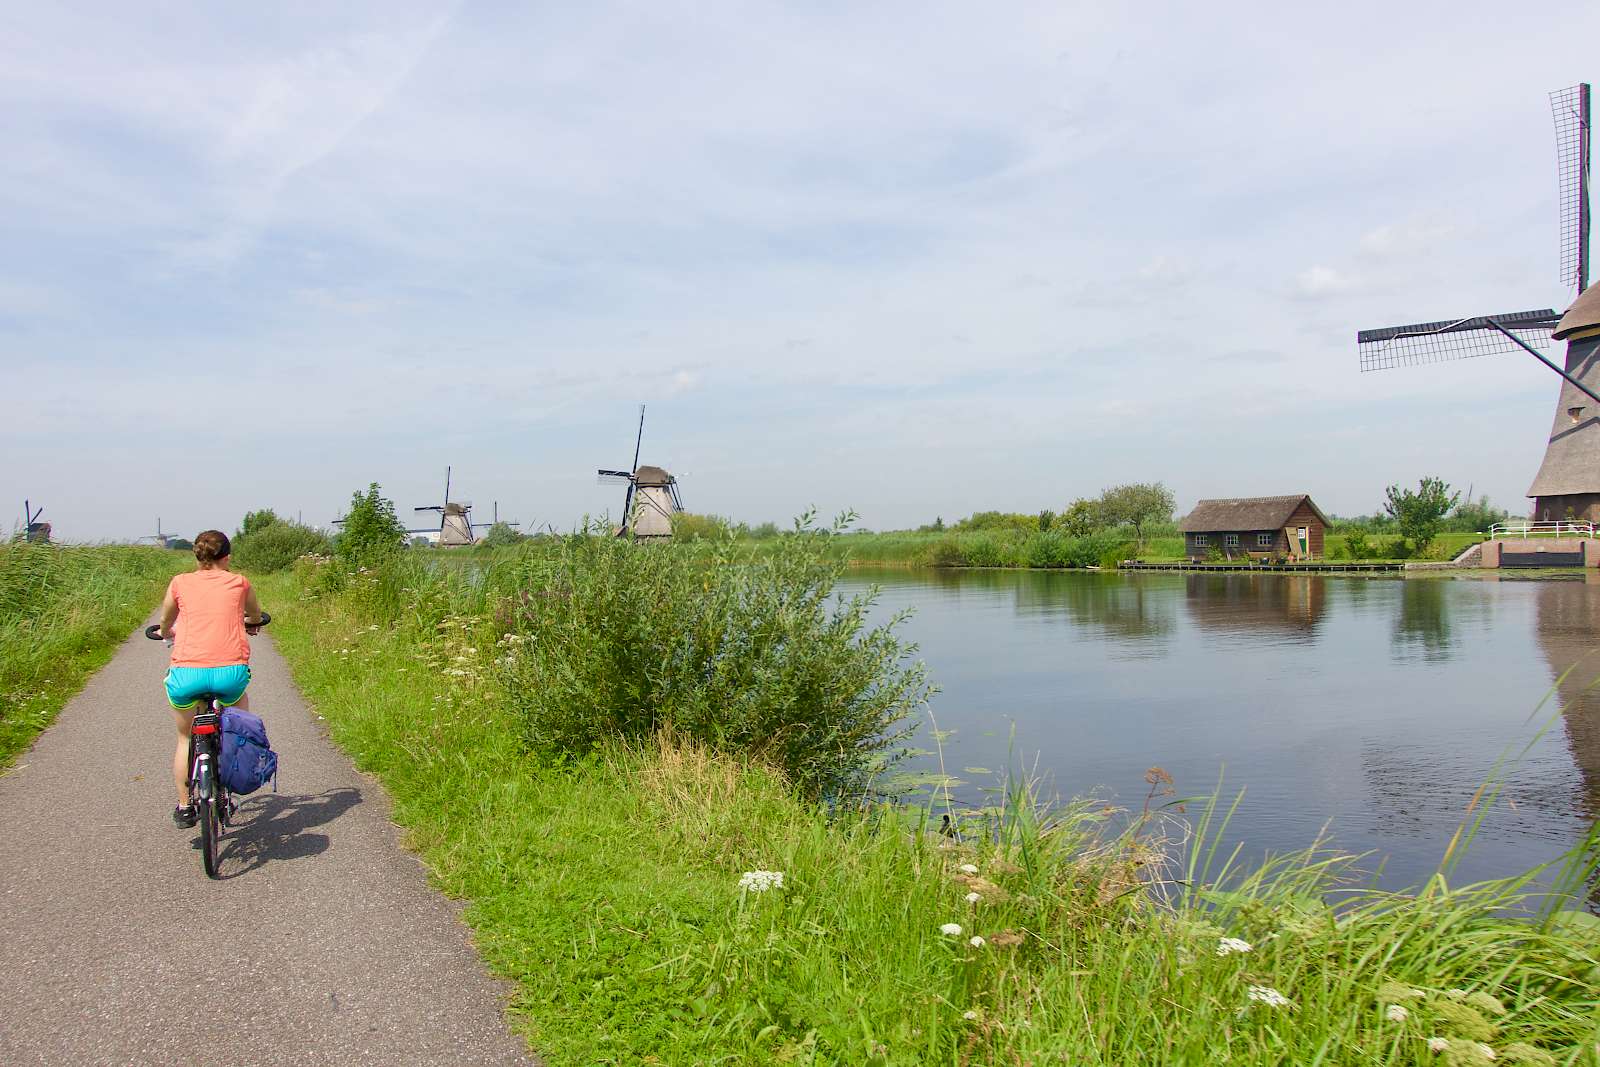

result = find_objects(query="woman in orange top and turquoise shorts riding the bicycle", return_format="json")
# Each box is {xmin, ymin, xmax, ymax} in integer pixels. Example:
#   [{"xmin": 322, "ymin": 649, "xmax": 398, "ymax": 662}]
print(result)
[{"xmin": 162, "ymin": 530, "xmax": 261, "ymax": 829}]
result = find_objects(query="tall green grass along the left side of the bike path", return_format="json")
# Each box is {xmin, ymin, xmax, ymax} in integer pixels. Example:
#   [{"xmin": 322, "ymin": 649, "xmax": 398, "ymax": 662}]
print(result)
[{"xmin": 0, "ymin": 542, "xmax": 194, "ymax": 766}]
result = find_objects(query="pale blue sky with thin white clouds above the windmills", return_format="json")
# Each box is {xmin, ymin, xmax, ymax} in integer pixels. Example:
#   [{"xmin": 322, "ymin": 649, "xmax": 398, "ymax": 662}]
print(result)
[{"xmin": 0, "ymin": 0, "xmax": 1600, "ymax": 541}]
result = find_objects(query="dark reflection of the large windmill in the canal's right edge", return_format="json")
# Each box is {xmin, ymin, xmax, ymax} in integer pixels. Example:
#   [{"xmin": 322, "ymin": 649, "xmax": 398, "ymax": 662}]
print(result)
[{"xmin": 1538, "ymin": 582, "xmax": 1600, "ymax": 814}]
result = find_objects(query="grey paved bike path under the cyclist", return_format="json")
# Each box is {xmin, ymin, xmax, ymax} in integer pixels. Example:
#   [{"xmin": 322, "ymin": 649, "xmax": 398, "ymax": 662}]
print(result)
[{"xmin": 0, "ymin": 635, "xmax": 536, "ymax": 1067}]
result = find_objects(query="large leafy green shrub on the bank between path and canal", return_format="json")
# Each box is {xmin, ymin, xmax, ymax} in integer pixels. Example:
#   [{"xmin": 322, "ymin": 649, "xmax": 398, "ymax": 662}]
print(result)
[{"xmin": 493, "ymin": 530, "xmax": 930, "ymax": 797}]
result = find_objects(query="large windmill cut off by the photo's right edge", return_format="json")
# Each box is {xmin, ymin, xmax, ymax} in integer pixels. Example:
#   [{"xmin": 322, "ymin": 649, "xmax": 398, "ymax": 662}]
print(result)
[{"xmin": 1355, "ymin": 82, "xmax": 1600, "ymax": 522}]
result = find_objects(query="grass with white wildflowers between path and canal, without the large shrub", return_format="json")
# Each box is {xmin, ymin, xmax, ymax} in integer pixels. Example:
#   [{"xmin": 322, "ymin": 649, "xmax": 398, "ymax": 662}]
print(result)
[{"xmin": 261, "ymin": 547, "xmax": 1600, "ymax": 1065}]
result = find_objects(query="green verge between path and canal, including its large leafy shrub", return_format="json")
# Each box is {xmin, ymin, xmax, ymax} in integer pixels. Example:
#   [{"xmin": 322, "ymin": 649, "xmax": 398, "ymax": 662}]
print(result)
[{"xmin": 259, "ymin": 534, "xmax": 1600, "ymax": 1065}]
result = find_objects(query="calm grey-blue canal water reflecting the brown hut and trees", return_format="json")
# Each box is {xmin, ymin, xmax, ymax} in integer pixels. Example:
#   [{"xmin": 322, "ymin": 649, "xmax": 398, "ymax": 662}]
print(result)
[{"xmin": 846, "ymin": 568, "xmax": 1600, "ymax": 888}]
